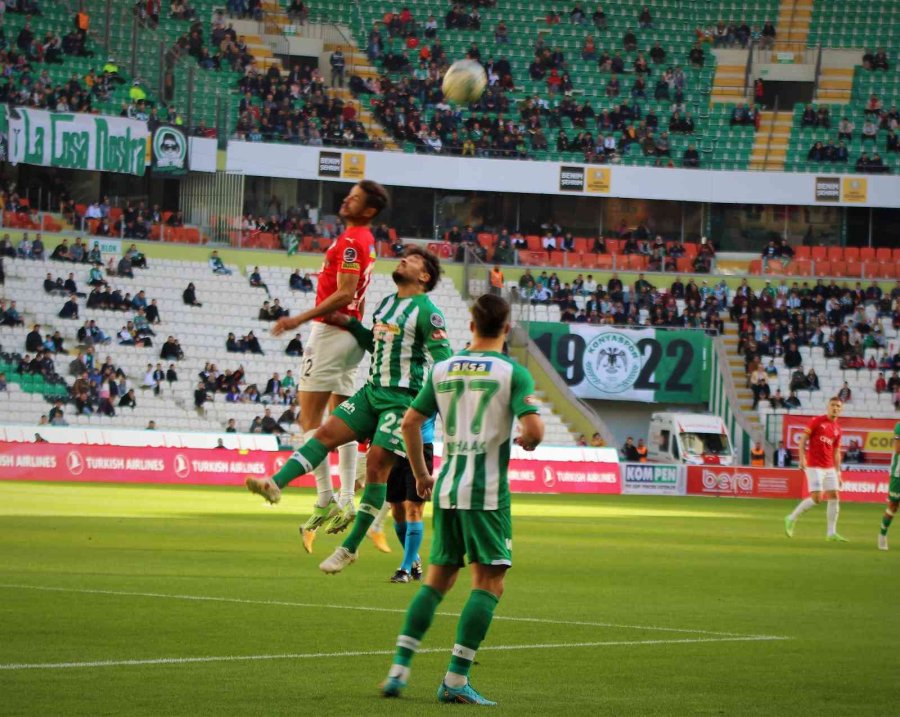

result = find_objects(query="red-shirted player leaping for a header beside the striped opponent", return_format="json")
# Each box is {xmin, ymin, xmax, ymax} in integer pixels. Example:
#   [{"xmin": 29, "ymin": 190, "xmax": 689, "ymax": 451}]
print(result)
[{"xmin": 272, "ymin": 179, "xmax": 389, "ymax": 553}]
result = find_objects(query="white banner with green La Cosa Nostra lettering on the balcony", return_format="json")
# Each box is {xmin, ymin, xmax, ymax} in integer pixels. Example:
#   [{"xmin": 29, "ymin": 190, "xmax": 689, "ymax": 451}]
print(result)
[{"xmin": 4, "ymin": 107, "xmax": 149, "ymax": 176}]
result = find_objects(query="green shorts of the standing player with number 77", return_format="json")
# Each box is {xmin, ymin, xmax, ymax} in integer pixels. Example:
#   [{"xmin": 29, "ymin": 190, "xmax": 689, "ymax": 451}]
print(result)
[{"xmin": 430, "ymin": 505, "xmax": 512, "ymax": 567}]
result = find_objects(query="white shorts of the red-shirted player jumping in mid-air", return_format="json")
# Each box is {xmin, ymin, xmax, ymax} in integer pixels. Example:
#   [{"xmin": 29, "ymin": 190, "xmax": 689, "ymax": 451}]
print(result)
[{"xmin": 297, "ymin": 321, "xmax": 365, "ymax": 396}]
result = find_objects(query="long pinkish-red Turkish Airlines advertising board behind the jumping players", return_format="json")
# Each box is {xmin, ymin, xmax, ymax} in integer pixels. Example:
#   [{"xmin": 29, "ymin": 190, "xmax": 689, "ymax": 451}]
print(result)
[{"xmin": 0, "ymin": 443, "xmax": 621, "ymax": 494}]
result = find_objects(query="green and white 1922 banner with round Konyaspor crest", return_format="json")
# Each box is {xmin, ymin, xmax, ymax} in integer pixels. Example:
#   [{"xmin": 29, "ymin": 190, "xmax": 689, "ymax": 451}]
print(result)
[{"xmin": 529, "ymin": 322, "xmax": 711, "ymax": 403}]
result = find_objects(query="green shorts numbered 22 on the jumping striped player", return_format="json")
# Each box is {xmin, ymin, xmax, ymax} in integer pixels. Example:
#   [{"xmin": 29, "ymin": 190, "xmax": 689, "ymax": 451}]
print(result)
[{"xmin": 331, "ymin": 384, "xmax": 415, "ymax": 458}]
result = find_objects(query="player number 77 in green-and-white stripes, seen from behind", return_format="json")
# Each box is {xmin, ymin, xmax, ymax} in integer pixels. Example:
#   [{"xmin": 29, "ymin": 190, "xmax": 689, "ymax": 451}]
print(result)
[{"xmin": 382, "ymin": 294, "xmax": 544, "ymax": 705}]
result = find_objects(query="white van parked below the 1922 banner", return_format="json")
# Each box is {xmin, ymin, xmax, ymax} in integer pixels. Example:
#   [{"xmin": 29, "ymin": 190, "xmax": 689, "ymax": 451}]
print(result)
[{"xmin": 647, "ymin": 412, "xmax": 735, "ymax": 466}]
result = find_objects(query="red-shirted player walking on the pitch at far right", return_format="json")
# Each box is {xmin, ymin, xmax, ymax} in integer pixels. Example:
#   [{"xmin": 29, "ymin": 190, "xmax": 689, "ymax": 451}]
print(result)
[{"xmin": 784, "ymin": 396, "xmax": 847, "ymax": 543}]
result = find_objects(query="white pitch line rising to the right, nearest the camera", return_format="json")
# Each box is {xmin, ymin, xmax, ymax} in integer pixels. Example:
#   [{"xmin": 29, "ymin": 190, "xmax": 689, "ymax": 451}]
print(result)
[{"xmin": 0, "ymin": 636, "xmax": 789, "ymax": 672}]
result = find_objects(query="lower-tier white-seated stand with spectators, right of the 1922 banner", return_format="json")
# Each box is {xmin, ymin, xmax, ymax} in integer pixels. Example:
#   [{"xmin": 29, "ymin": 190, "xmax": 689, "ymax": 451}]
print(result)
[{"xmin": 726, "ymin": 280, "xmax": 900, "ymax": 428}]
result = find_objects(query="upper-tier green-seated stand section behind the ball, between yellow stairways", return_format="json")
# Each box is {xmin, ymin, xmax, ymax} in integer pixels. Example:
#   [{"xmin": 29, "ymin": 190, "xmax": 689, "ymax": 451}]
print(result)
[{"xmin": 209, "ymin": 0, "xmax": 777, "ymax": 169}]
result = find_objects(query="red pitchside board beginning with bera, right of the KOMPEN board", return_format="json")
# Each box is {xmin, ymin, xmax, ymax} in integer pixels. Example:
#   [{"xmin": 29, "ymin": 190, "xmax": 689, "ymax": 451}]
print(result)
[{"xmin": 687, "ymin": 466, "xmax": 888, "ymax": 503}]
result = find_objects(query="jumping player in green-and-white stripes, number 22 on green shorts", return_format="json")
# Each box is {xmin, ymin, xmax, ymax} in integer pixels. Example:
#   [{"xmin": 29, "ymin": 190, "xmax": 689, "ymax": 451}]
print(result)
[{"xmin": 246, "ymin": 247, "xmax": 451, "ymax": 573}]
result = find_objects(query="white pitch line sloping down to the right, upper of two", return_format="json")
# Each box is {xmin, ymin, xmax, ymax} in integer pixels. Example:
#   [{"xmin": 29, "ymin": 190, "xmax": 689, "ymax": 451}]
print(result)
[{"xmin": 0, "ymin": 583, "xmax": 786, "ymax": 639}]
